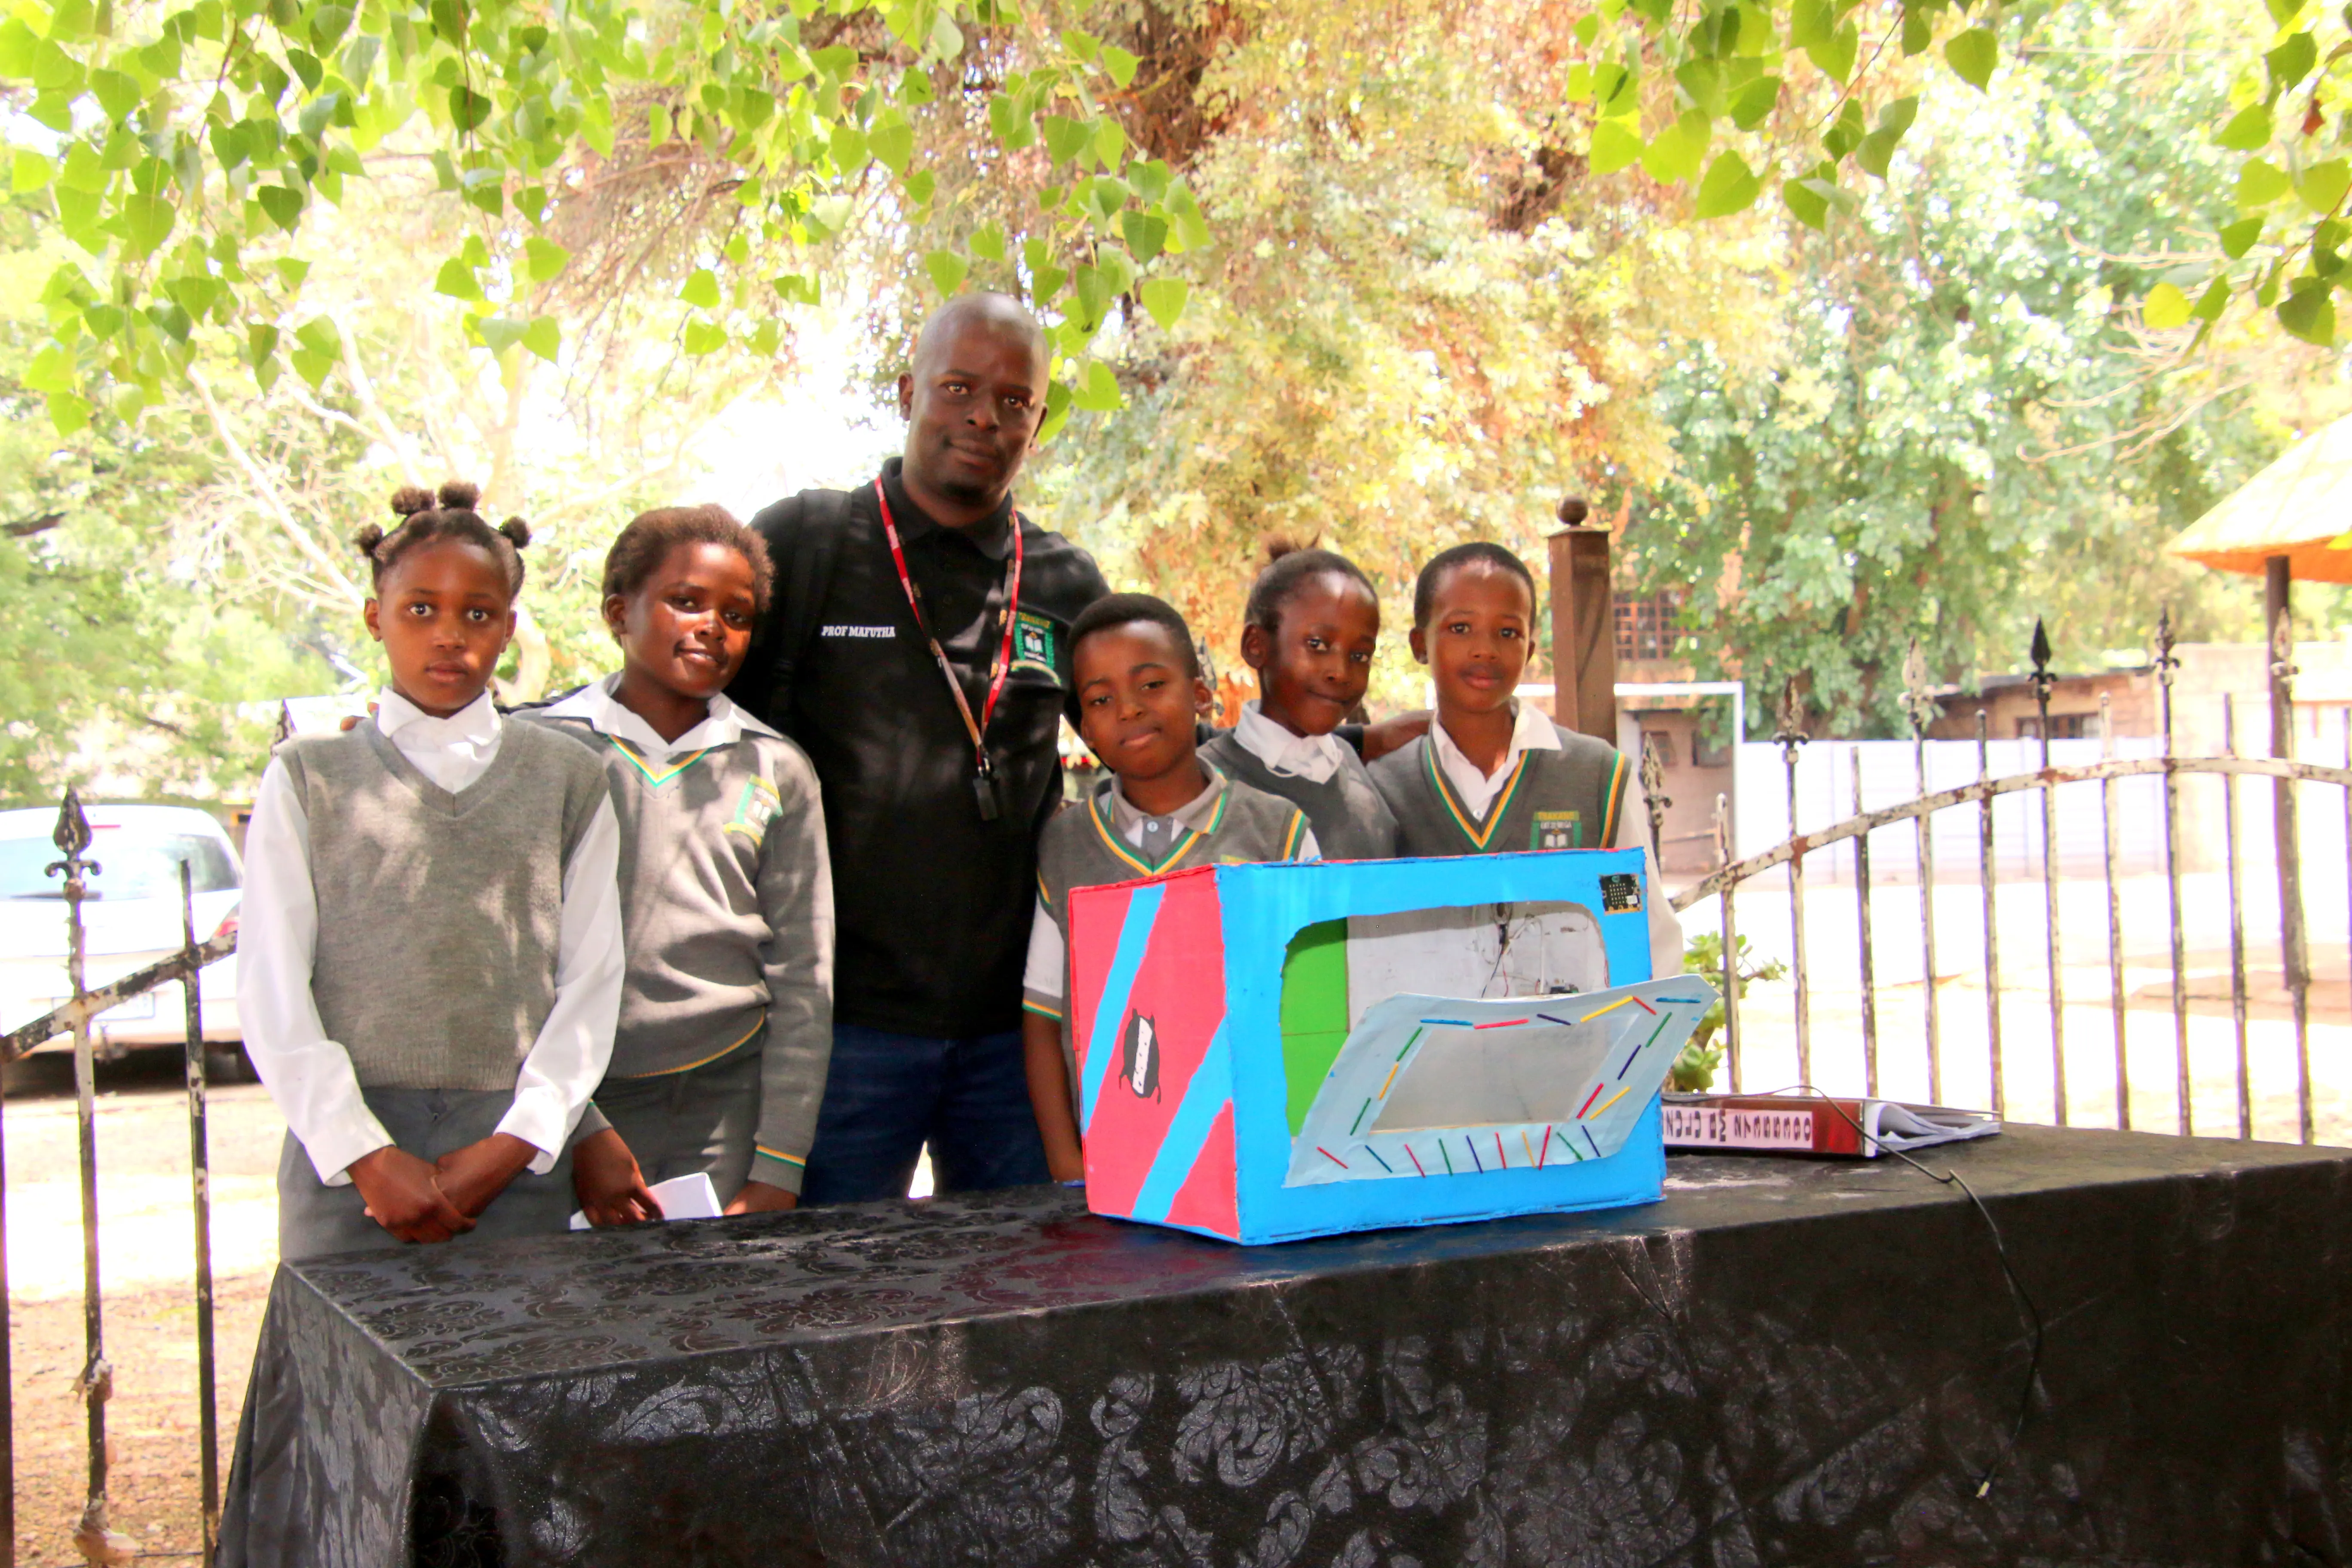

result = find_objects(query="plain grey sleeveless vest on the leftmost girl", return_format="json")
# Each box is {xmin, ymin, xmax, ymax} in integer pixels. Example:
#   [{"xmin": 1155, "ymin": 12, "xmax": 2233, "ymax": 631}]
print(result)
[{"xmin": 278, "ymin": 722, "xmax": 604, "ymax": 1091}]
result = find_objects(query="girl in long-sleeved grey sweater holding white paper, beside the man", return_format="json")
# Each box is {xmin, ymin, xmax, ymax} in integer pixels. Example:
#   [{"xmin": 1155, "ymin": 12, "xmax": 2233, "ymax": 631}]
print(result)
[{"xmin": 520, "ymin": 505, "xmax": 833, "ymax": 1222}]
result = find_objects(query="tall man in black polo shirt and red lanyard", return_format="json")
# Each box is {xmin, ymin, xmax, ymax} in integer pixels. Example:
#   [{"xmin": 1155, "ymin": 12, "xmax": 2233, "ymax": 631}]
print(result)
[{"xmin": 732, "ymin": 294, "xmax": 1108, "ymax": 1204}]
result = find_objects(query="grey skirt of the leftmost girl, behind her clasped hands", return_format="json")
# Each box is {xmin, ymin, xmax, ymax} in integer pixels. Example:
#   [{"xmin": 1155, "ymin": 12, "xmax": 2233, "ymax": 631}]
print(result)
[{"xmin": 278, "ymin": 1088, "xmax": 576, "ymax": 1262}]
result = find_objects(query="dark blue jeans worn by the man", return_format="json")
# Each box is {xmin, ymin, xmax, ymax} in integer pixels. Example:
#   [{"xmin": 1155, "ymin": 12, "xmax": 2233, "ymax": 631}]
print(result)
[{"xmin": 799, "ymin": 1023, "xmax": 1049, "ymax": 1206}]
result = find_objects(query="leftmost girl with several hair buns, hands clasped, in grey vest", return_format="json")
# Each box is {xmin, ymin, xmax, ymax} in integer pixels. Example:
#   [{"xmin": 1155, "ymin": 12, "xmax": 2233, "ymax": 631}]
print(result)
[{"xmin": 238, "ymin": 484, "xmax": 623, "ymax": 1260}]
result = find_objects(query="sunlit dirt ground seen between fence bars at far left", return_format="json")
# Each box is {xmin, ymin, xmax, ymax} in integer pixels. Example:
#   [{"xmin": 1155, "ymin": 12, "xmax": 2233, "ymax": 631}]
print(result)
[{"xmin": 5, "ymin": 1051, "xmax": 285, "ymax": 1568}]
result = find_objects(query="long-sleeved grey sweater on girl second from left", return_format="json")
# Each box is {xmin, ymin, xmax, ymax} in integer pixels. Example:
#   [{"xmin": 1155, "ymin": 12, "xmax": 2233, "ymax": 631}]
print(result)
[{"xmin": 515, "ymin": 710, "xmax": 833, "ymax": 1192}]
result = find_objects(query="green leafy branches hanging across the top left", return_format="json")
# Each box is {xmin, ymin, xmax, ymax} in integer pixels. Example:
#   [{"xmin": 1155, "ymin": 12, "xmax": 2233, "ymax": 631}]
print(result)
[{"xmin": 0, "ymin": 0, "xmax": 1207, "ymax": 430}]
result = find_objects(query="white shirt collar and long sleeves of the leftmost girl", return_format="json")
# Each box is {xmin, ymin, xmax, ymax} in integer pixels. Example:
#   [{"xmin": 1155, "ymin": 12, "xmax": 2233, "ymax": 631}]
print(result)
[{"xmin": 238, "ymin": 686, "xmax": 626, "ymax": 1187}]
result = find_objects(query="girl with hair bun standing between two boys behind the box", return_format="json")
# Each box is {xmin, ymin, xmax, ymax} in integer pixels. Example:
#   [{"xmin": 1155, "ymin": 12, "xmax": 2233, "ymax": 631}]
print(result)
[{"xmin": 1200, "ymin": 538, "xmax": 1397, "ymax": 861}]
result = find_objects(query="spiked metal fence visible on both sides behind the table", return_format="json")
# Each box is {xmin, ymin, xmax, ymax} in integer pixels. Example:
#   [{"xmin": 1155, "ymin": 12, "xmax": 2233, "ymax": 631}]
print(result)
[{"xmin": 0, "ymin": 611, "xmax": 2352, "ymax": 1568}]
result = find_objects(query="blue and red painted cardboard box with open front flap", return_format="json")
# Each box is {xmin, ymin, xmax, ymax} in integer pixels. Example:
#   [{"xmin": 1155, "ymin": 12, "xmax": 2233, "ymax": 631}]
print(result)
[{"xmin": 1070, "ymin": 848, "xmax": 1715, "ymax": 1243}]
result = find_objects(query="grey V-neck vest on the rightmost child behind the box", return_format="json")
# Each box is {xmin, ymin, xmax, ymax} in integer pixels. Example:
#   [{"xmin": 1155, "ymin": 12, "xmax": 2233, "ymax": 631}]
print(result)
[{"xmin": 1369, "ymin": 724, "xmax": 1632, "ymax": 856}]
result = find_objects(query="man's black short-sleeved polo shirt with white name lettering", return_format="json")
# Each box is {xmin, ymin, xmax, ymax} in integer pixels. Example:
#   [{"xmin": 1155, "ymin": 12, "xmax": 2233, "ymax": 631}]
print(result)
[{"xmin": 734, "ymin": 459, "xmax": 1110, "ymax": 1037}]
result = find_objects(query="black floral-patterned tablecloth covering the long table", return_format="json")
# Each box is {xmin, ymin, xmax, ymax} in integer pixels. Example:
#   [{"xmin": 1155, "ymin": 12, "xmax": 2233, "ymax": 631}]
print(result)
[{"xmin": 224, "ymin": 1128, "xmax": 2352, "ymax": 1568}]
